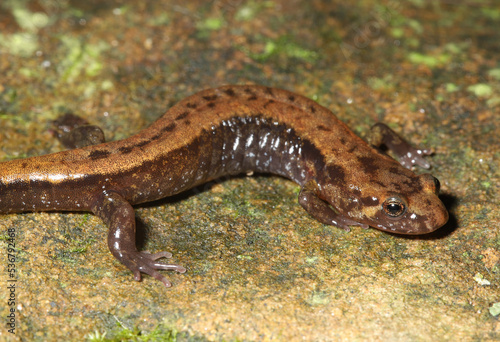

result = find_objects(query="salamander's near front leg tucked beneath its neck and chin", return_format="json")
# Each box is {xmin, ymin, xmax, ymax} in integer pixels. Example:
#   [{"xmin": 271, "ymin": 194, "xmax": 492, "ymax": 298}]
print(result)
[{"xmin": 299, "ymin": 181, "xmax": 368, "ymax": 231}]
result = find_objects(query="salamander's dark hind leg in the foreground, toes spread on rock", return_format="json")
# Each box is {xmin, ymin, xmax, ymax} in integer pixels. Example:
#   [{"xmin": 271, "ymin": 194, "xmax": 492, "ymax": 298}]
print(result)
[{"xmin": 92, "ymin": 192, "xmax": 186, "ymax": 287}]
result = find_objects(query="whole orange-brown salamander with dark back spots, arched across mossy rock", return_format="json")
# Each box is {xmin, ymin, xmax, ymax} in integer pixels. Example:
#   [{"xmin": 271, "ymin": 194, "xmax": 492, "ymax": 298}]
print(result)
[{"xmin": 0, "ymin": 85, "xmax": 448, "ymax": 287}]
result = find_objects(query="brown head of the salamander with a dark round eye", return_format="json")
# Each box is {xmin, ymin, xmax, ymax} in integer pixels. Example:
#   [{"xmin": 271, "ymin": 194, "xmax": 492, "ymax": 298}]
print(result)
[{"xmin": 360, "ymin": 174, "xmax": 448, "ymax": 235}]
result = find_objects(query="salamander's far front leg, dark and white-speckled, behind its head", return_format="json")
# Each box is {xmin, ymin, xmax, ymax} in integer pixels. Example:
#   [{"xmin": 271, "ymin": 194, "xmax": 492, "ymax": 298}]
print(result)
[{"xmin": 367, "ymin": 123, "xmax": 432, "ymax": 169}]
